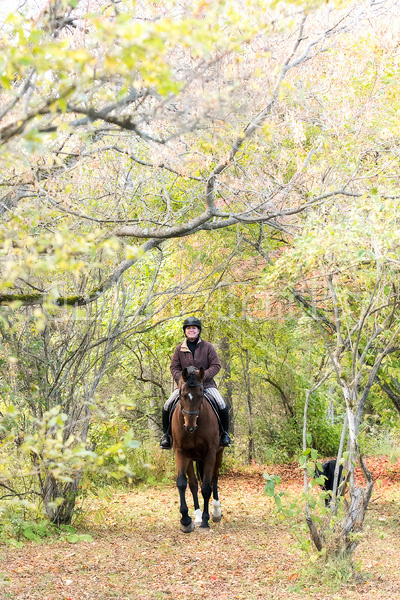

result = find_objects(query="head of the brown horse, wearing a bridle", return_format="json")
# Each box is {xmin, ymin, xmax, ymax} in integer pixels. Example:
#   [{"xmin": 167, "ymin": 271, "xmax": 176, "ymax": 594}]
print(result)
[{"xmin": 179, "ymin": 367, "xmax": 204, "ymax": 433}]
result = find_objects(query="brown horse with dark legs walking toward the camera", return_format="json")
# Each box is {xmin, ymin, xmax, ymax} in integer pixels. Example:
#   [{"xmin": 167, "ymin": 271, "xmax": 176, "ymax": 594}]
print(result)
[{"xmin": 171, "ymin": 367, "xmax": 224, "ymax": 533}]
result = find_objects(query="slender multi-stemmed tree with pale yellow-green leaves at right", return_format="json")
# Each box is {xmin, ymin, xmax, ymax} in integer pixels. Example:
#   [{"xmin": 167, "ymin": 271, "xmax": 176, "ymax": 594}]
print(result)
[{"xmin": 270, "ymin": 197, "xmax": 400, "ymax": 554}]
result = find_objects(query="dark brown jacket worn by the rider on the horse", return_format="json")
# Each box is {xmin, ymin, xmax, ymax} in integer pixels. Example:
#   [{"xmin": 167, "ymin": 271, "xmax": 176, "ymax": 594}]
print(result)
[{"xmin": 170, "ymin": 338, "xmax": 221, "ymax": 388}]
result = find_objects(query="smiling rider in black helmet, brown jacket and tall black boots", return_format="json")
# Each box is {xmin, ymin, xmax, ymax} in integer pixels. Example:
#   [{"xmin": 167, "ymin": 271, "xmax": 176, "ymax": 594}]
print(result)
[{"xmin": 160, "ymin": 317, "xmax": 231, "ymax": 450}]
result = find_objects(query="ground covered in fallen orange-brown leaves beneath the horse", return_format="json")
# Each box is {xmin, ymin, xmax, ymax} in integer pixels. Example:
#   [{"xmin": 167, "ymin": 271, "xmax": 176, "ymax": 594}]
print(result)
[{"xmin": 0, "ymin": 457, "xmax": 400, "ymax": 600}]
